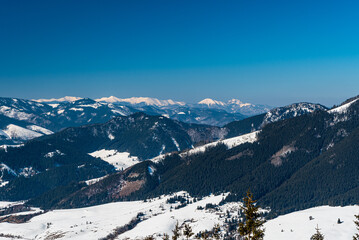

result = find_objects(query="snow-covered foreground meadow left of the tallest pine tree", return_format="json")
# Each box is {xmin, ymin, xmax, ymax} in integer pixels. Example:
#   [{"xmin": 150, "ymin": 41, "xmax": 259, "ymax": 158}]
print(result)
[{"xmin": 0, "ymin": 192, "xmax": 231, "ymax": 240}]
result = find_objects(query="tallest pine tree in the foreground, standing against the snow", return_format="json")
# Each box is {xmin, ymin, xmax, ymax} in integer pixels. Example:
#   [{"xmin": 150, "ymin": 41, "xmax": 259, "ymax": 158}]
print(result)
[{"xmin": 238, "ymin": 189, "xmax": 265, "ymax": 240}]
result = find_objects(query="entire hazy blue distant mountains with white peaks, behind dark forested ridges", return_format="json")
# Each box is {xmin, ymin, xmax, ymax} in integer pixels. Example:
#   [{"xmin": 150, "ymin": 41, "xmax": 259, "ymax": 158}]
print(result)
[{"xmin": 0, "ymin": 96, "xmax": 269, "ymax": 146}]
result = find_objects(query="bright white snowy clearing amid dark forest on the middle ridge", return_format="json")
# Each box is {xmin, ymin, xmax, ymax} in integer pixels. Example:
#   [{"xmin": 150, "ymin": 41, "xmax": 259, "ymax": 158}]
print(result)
[{"xmin": 89, "ymin": 149, "xmax": 140, "ymax": 170}]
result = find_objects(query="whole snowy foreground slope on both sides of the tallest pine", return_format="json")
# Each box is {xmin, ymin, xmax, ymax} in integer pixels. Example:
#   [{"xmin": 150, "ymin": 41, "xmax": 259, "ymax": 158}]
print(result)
[{"xmin": 0, "ymin": 192, "xmax": 359, "ymax": 240}]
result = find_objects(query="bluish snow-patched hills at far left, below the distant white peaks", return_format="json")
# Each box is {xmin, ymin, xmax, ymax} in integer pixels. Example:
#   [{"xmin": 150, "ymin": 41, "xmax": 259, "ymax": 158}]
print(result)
[{"xmin": 0, "ymin": 98, "xmax": 136, "ymax": 145}]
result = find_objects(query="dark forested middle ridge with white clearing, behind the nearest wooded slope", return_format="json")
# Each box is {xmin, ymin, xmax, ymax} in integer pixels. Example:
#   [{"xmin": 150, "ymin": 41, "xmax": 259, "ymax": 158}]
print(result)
[{"xmin": 0, "ymin": 96, "xmax": 325, "ymax": 210}]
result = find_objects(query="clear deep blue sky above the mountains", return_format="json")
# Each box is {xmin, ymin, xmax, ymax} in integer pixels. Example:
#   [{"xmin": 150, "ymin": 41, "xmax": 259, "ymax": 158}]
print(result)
[{"xmin": 0, "ymin": 0, "xmax": 359, "ymax": 106}]
